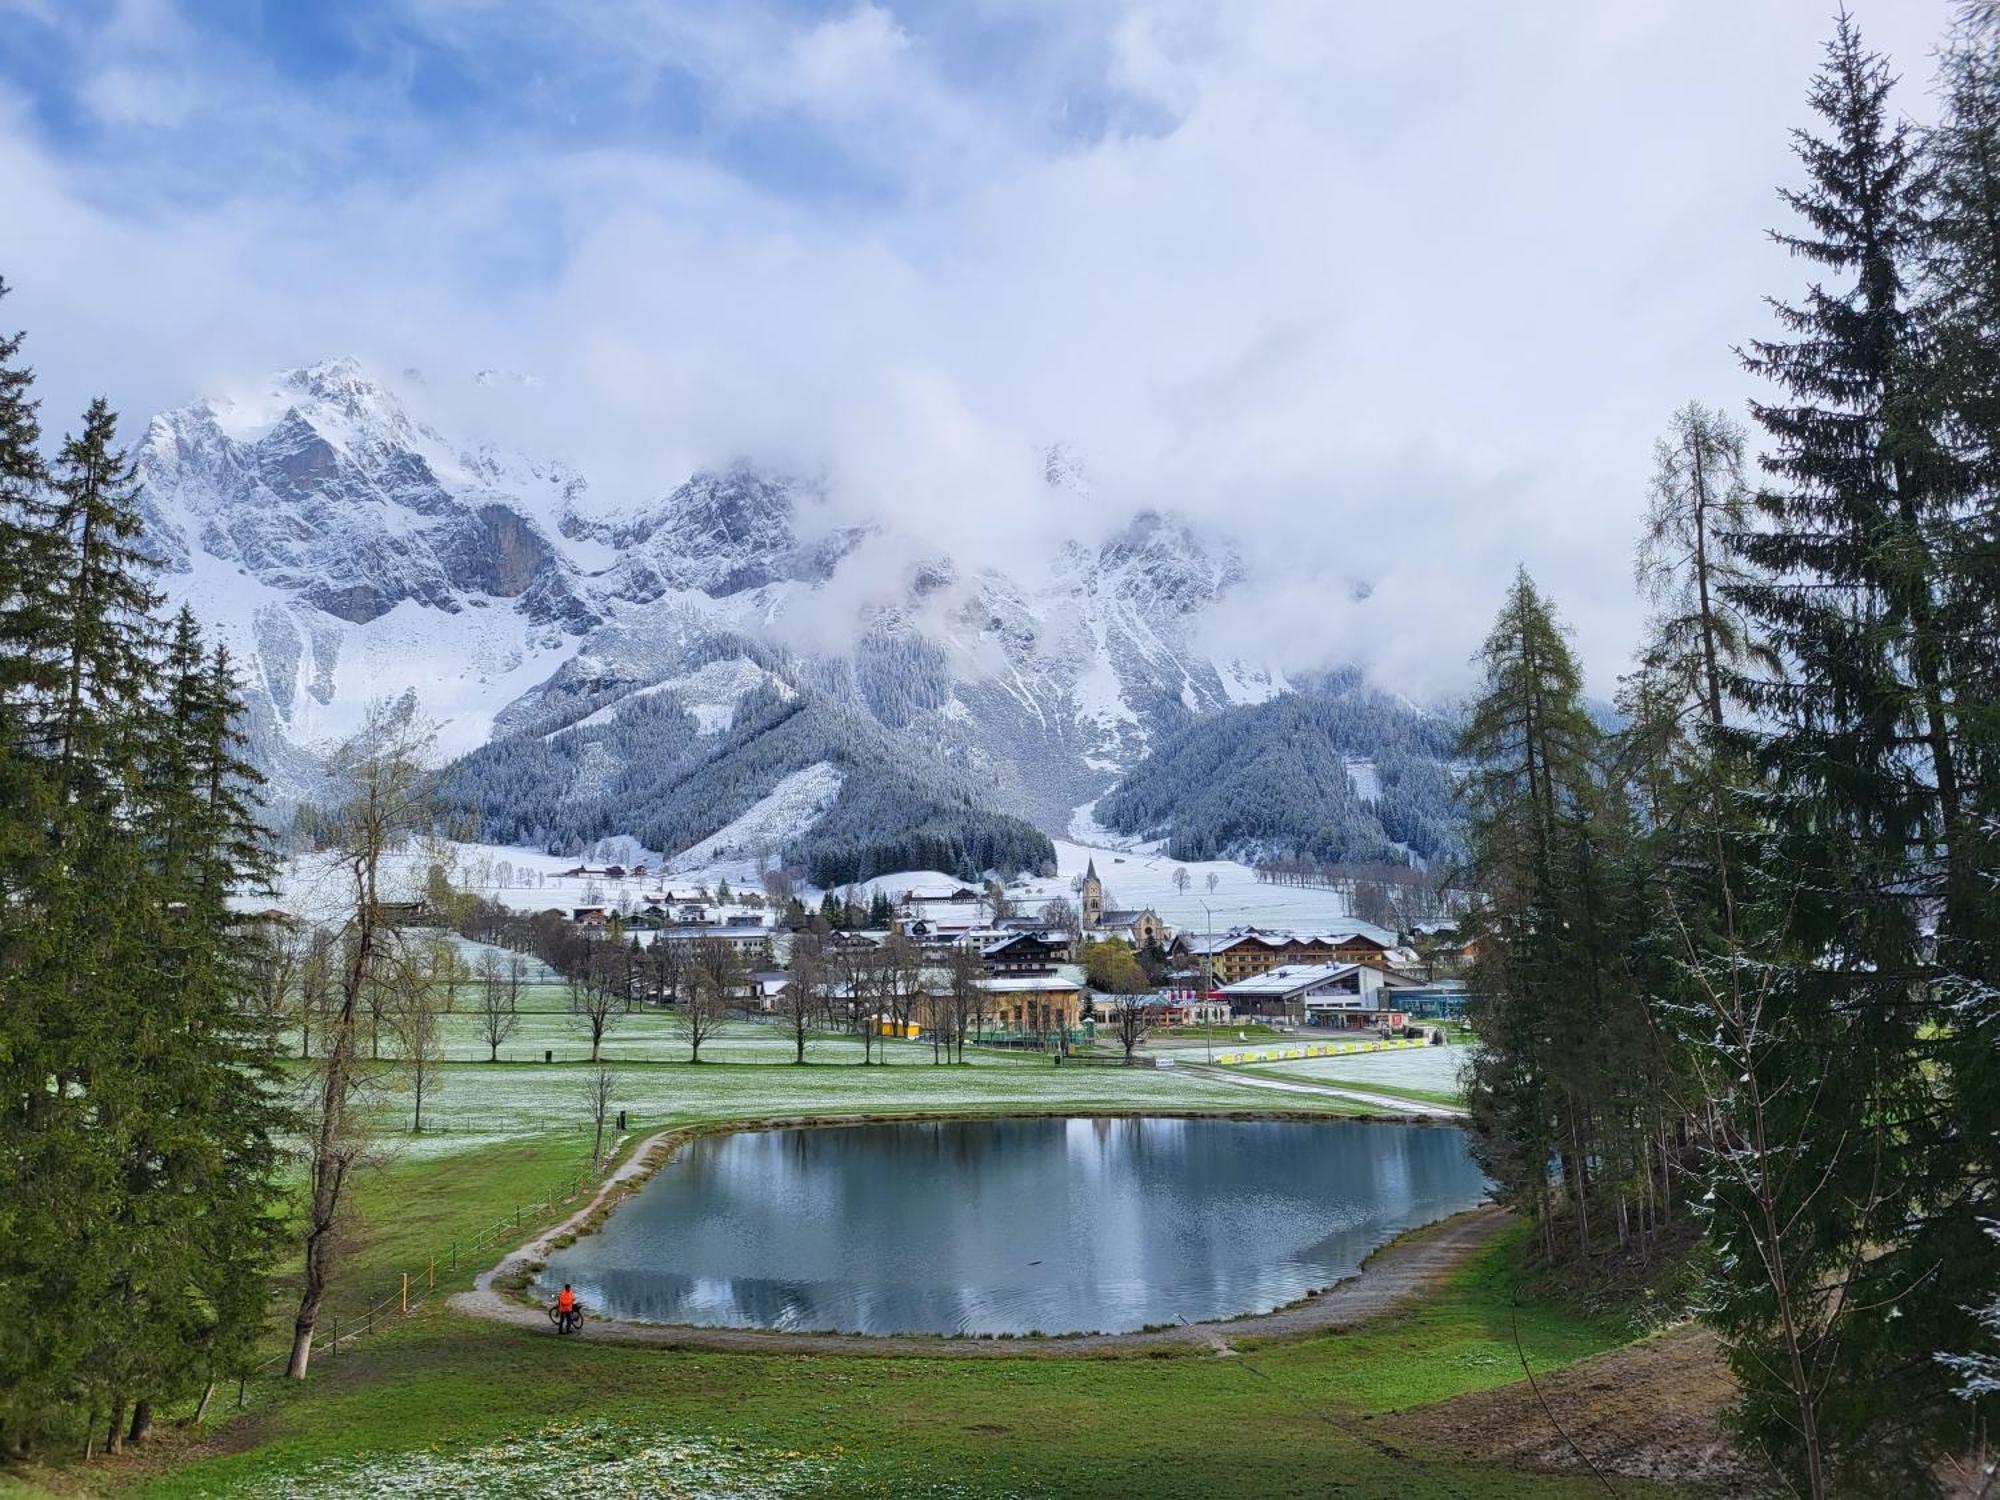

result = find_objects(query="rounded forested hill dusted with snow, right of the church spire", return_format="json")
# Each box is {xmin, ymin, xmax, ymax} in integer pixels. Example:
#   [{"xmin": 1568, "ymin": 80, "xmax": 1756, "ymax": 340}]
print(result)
[{"xmin": 1094, "ymin": 674, "xmax": 1460, "ymax": 862}]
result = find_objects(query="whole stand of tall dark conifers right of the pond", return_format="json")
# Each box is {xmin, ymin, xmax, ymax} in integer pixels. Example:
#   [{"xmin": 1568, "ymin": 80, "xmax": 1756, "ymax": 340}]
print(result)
[{"xmin": 1462, "ymin": 12, "xmax": 2000, "ymax": 1496}]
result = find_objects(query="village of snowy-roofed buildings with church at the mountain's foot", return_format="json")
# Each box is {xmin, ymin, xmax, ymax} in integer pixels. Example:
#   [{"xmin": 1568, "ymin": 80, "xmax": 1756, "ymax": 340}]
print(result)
[{"xmin": 426, "ymin": 846, "xmax": 1466, "ymax": 1060}]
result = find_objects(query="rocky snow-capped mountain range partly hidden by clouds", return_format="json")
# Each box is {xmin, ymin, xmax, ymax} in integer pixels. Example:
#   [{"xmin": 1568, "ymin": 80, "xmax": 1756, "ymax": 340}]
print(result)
[{"xmin": 138, "ymin": 360, "xmax": 1284, "ymax": 864}]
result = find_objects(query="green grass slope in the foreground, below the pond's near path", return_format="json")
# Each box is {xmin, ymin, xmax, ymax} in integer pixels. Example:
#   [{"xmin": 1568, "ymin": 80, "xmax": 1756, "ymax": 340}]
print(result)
[{"xmin": 130, "ymin": 1208, "xmax": 1664, "ymax": 1498}]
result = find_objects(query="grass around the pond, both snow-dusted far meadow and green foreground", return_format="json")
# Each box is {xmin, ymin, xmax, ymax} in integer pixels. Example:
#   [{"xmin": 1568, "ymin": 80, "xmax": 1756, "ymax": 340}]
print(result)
[{"xmin": 0, "ymin": 944, "xmax": 1670, "ymax": 1500}]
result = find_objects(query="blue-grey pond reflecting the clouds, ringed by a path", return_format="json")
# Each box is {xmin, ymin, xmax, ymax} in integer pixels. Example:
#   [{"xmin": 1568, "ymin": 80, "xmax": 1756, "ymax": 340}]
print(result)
[{"xmin": 538, "ymin": 1118, "xmax": 1486, "ymax": 1334}]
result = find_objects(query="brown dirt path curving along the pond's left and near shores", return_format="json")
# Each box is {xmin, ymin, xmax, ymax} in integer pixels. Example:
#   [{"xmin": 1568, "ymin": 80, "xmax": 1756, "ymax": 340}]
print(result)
[{"xmin": 450, "ymin": 1130, "xmax": 1508, "ymax": 1358}]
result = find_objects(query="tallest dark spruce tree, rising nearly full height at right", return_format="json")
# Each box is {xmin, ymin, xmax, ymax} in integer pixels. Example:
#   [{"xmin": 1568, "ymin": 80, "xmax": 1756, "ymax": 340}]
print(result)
[{"xmin": 1710, "ymin": 16, "xmax": 1994, "ymax": 1494}]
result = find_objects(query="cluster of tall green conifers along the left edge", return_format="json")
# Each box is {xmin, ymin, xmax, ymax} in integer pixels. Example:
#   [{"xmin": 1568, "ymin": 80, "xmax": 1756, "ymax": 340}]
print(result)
[{"xmin": 0, "ymin": 286, "xmax": 288, "ymax": 1452}]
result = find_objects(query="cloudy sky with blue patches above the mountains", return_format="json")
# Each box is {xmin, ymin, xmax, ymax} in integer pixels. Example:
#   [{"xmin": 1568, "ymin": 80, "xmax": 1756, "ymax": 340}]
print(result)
[{"xmin": 0, "ymin": 0, "xmax": 1948, "ymax": 690}]
